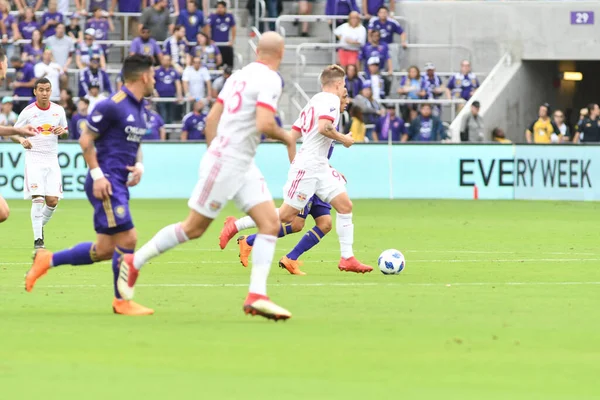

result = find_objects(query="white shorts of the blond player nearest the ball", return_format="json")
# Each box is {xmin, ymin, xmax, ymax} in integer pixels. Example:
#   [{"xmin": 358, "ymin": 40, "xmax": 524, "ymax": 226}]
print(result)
[{"xmin": 283, "ymin": 165, "xmax": 346, "ymax": 210}]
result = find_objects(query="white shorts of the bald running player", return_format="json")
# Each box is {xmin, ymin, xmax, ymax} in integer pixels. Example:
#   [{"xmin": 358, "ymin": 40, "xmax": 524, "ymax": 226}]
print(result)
[{"xmin": 188, "ymin": 154, "xmax": 273, "ymax": 219}]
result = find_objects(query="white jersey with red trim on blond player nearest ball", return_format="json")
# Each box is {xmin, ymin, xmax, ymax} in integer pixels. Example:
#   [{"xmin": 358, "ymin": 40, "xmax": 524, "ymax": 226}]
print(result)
[{"xmin": 292, "ymin": 92, "xmax": 340, "ymax": 165}]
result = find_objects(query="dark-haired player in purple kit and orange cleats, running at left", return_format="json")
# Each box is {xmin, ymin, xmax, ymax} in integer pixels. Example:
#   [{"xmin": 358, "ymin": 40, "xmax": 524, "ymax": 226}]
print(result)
[{"xmin": 25, "ymin": 55, "xmax": 154, "ymax": 315}]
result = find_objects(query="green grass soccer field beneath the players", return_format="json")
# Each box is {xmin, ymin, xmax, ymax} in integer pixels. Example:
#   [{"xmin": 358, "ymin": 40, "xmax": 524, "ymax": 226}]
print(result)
[{"xmin": 0, "ymin": 200, "xmax": 600, "ymax": 400}]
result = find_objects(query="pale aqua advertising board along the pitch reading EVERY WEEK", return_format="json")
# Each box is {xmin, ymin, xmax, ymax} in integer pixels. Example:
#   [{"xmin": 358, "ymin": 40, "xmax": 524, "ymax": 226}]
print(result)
[{"xmin": 0, "ymin": 143, "xmax": 600, "ymax": 200}]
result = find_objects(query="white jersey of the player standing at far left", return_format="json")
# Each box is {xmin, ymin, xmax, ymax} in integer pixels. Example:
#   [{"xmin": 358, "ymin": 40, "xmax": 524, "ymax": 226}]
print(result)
[{"xmin": 15, "ymin": 102, "xmax": 68, "ymax": 164}]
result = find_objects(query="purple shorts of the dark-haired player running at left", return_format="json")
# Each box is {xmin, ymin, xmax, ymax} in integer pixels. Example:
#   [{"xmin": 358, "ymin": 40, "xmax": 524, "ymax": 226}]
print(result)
[{"xmin": 85, "ymin": 173, "xmax": 133, "ymax": 235}]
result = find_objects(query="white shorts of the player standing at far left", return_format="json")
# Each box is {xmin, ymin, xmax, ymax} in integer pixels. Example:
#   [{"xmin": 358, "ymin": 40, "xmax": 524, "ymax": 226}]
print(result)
[{"xmin": 23, "ymin": 163, "xmax": 63, "ymax": 200}]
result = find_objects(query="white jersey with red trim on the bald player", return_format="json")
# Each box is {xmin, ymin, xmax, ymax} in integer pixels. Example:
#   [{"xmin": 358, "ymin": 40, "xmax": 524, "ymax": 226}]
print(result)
[{"xmin": 209, "ymin": 62, "xmax": 283, "ymax": 163}]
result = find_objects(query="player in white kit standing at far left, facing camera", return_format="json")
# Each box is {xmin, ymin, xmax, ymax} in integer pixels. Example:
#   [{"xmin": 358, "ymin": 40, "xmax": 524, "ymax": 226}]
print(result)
[{"xmin": 12, "ymin": 78, "xmax": 68, "ymax": 249}]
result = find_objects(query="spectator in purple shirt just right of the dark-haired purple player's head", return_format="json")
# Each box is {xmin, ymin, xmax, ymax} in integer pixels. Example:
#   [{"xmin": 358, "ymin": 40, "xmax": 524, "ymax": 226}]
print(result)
[{"xmin": 154, "ymin": 54, "xmax": 183, "ymax": 124}]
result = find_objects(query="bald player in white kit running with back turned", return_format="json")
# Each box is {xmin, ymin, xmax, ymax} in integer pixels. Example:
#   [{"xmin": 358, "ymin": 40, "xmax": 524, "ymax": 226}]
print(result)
[{"xmin": 117, "ymin": 32, "xmax": 296, "ymax": 320}]
